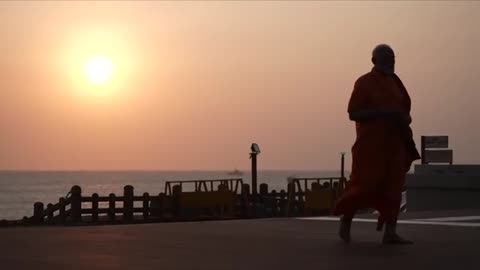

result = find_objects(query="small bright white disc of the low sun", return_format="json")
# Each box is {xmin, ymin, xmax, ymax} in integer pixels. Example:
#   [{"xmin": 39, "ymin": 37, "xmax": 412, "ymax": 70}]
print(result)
[{"xmin": 85, "ymin": 56, "xmax": 113, "ymax": 84}]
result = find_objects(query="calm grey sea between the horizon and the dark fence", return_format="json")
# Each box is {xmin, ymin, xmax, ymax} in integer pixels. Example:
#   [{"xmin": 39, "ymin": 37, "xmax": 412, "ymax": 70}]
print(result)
[{"xmin": 0, "ymin": 171, "xmax": 340, "ymax": 219}]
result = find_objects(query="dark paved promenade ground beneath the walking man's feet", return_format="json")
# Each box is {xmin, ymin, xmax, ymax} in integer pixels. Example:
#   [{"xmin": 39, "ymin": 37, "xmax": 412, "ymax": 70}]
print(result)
[{"xmin": 0, "ymin": 210, "xmax": 480, "ymax": 270}]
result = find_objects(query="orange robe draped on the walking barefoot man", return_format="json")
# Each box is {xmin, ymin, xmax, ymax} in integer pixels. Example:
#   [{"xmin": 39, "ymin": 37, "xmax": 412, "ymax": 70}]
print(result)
[{"xmin": 334, "ymin": 69, "xmax": 420, "ymax": 223}]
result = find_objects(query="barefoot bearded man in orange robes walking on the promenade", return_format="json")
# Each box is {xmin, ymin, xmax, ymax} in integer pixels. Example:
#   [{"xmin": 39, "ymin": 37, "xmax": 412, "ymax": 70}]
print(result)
[{"xmin": 335, "ymin": 44, "xmax": 420, "ymax": 244}]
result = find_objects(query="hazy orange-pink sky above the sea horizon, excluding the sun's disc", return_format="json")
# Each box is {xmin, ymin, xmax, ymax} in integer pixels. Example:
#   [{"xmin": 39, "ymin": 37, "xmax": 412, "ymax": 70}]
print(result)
[{"xmin": 0, "ymin": 1, "xmax": 480, "ymax": 169}]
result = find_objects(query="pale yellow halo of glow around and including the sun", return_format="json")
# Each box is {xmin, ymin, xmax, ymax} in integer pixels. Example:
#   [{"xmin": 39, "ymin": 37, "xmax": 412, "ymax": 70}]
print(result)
[{"xmin": 59, "ymin": 26, "xmax": 139, "ymax": 102}]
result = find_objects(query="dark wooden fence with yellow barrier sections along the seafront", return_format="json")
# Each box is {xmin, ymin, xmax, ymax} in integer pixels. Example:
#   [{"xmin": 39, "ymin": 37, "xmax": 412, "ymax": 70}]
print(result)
[{"xmin": 14, "ymin": 177, "xmax": 346, "ymax": 227}]
